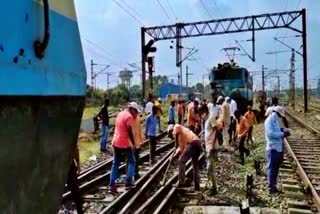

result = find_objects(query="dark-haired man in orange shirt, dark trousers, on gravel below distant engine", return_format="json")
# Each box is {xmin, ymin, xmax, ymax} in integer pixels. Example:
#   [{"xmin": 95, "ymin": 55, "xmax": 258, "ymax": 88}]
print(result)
[{"xmin": 234, "ymin": 110, "xmax": 250, "ymax": 165}]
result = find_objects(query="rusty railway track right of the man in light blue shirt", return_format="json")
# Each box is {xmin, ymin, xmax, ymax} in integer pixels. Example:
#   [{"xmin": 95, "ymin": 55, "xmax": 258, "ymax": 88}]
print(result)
[{"xmin": 280, "ymin": 111, "xmax": 320, "ymax": 213}]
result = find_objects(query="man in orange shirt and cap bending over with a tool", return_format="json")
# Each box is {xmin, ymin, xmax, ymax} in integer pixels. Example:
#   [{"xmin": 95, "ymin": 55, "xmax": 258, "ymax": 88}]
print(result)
[{"xmin": 167, "ymin": 124, "xmax": 201, "ymax": 191}]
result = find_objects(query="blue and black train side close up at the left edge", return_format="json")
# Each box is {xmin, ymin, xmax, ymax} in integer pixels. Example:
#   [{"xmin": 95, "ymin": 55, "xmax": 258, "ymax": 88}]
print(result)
[{"xmin": 0, "ymin": 0, "xmax": 86, "ymax": 213}]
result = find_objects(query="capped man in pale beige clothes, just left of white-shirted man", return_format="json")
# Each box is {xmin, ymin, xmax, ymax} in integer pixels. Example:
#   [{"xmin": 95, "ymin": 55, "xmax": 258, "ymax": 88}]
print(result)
[{"xmin": 217, "ymin": 96, "xmax": 230, "ymax": 146}]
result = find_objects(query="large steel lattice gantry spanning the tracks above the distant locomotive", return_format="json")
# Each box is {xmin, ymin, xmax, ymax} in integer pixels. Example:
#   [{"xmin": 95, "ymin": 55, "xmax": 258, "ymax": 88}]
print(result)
[{"xmin": 141, "ymin": 9, "xmax": 308, "ymax": 112}]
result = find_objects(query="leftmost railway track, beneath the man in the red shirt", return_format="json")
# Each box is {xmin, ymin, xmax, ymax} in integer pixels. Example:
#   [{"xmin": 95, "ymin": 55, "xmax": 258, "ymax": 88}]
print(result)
[{"xmin": 62, "ymin": 133, "xmax": 174, "ymax": 213}]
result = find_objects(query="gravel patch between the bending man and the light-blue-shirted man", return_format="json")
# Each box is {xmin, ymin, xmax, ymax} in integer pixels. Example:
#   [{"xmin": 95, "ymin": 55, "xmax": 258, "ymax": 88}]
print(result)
[{"xmin": 206, "ymin": 124, "xmax": 285, "ymax": 209}]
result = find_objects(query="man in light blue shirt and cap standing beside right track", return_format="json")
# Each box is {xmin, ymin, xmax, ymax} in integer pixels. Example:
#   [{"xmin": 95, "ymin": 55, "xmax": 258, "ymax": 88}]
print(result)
[{"xmin": 264, "ymin": 106, "xmax": 290, "ymax": 194}]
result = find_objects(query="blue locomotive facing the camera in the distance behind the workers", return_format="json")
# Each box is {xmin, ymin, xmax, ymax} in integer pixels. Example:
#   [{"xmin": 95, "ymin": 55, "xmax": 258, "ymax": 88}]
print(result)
[{"xmin": 209, "ymin": 62, "xmax": 253, "ymax": 113}]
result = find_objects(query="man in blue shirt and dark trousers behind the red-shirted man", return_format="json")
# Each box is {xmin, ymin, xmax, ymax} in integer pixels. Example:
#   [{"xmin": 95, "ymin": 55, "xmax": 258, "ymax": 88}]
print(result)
[{"xmin": 145, "ymin": 105, "xmax": 158, "ymax": 165}]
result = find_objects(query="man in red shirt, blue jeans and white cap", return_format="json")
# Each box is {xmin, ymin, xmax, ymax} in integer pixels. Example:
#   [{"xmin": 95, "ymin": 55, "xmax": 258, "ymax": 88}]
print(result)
[{"xmin": 110, "ymin": 102, "xmax": 140, "ymax": 195}]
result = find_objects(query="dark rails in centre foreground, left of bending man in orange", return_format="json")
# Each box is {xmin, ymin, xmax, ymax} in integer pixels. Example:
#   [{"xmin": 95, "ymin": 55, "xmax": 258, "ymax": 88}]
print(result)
[{"xmin": 99, "ymin": 150, "xmax": 204, "ymax": 214}]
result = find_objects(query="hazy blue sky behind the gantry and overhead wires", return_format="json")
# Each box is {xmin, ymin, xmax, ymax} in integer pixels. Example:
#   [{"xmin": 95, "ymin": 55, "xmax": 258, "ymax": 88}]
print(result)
[{"xmin": 75, "ymin": 0, "xmax": 320, "ymax": 89}]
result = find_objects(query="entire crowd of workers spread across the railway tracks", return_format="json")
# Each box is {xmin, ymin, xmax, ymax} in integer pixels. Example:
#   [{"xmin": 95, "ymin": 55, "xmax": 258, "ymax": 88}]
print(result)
[{"xmin": 68, "ymin": 96, "xmax": 290, "ymax": 213}]
